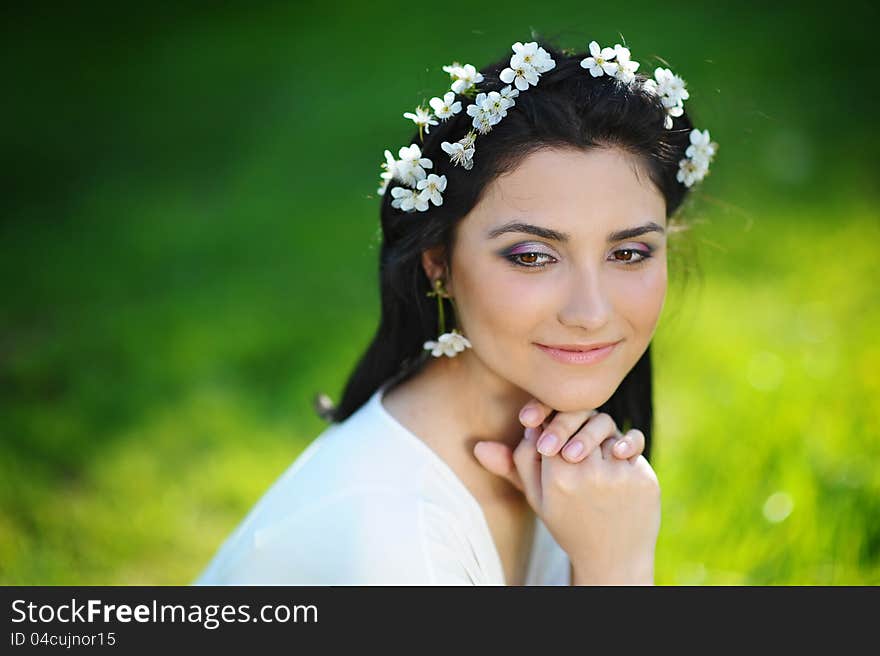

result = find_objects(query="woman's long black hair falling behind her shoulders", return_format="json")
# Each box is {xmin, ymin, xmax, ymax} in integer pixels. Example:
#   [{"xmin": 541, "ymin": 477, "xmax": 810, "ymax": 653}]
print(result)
[{"xmin": 316, "ymin": 39, "xmax": 692, "ymax": 458}]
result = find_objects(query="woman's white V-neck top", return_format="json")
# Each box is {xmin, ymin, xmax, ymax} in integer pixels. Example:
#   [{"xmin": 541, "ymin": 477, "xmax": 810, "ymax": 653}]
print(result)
[{"xmin": 194, "ymin": 383, "xmax": 570, "ymax": 586}]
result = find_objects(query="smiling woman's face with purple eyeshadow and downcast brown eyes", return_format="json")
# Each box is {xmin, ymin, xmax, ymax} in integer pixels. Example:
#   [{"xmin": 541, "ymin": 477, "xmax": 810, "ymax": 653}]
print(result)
[{"xmin": 447, "ymin": 148, "xmax": 666, "ymax": 412}]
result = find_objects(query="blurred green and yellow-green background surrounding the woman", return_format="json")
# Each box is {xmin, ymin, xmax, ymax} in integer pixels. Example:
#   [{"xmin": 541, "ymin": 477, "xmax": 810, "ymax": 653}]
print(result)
[{"xmin": 0, "ymin": 0, "xmax": 880, "ymax": 585}]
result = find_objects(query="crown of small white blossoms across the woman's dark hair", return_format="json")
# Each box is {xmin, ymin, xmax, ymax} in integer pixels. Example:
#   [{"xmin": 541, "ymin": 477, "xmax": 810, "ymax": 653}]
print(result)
[{"xmin": 377, "ymin": 41, "xmax": 718, "ymax": 212}]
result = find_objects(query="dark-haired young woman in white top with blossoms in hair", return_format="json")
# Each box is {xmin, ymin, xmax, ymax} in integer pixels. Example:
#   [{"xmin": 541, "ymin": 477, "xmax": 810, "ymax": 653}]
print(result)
[{"xmin": 197, "ymin": 42, "xmax": 715, "ymax": 585}]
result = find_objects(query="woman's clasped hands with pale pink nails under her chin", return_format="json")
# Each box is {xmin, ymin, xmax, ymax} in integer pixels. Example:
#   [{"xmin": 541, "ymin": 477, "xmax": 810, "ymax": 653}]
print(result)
[{"xmin": 474, "ymin": 401, "xmax": 660, "ymax": 584}]
